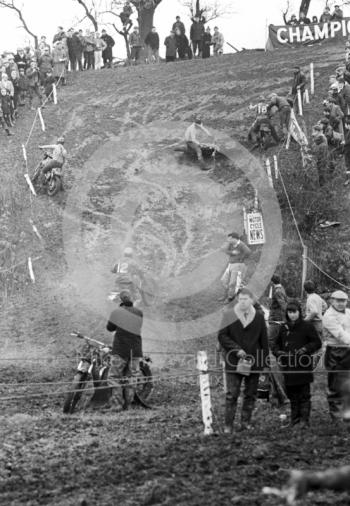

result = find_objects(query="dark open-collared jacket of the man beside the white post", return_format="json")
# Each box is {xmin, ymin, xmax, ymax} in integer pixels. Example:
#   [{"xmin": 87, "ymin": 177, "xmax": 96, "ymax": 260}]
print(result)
[{"xmin": 218, "ymin": 304, "xmax": 269, "ymax": 371}]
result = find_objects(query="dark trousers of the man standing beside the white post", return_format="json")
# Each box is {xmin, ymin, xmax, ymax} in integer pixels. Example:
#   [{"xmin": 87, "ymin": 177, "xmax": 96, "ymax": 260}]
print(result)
[{"xmin": 225, "ymin": 371, "xmax": 259, "ymax": 427}]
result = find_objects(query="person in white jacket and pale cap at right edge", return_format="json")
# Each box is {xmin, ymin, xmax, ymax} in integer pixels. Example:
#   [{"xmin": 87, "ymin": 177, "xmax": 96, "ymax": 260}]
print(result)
[{"xmin": 323, "ymin": 290, "xmax": 350, "ymax": 420}]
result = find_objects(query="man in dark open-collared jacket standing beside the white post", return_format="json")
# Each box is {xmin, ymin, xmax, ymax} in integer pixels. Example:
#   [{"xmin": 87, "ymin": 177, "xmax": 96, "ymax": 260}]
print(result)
[{"xmin": 218, "ymin": 288, "xmax": 269, "ymax": 434}]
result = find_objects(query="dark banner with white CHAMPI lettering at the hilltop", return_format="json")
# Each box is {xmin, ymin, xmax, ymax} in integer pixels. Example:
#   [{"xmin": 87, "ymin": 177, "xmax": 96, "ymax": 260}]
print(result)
[{"xmin": 266, "ymin": 18, "xmax": 350, "ymax": 51}]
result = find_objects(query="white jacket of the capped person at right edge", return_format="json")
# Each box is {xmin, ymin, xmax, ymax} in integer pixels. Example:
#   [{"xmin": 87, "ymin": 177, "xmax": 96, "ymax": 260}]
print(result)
[{"xmin": 322, "ymin": 306, "xmax": 350, "ymax": 347}]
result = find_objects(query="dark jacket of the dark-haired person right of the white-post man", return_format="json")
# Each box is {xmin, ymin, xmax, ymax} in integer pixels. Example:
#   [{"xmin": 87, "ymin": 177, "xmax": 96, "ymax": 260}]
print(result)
[{"xmin": 272, "ymin": 318, "xmax": 322, "ymax": 385}]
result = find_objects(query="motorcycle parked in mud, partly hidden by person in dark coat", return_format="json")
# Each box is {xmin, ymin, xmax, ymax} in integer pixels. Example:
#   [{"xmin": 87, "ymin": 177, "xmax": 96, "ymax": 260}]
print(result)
[{"xmin": 63, "ymin": 332, "xmax": 153, "ymax": 414}]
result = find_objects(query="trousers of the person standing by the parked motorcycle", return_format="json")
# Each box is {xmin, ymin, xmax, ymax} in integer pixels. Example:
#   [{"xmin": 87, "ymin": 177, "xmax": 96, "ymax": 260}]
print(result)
[{"xmin": 108, "ymin": 355, "xmax": 140, "ymax": 409}]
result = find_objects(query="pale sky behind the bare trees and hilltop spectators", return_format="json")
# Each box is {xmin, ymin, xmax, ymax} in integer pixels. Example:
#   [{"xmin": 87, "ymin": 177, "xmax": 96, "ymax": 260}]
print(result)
[{"xmin": 0, "ymin": 0, "xmax": 350, "ymax": 58}]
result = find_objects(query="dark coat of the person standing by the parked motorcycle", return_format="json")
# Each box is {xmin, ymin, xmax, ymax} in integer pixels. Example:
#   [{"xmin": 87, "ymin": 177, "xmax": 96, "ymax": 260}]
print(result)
[{"xmin": 107, "ymin": 302, "xmax": 143, "ymax": 360}]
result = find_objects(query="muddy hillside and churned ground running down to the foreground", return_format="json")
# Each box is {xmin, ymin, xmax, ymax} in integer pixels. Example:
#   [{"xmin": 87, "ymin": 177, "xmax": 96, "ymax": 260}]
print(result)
[{"xmin": 0, "ymin": 42, "xmax": 350, "ymax": 506}]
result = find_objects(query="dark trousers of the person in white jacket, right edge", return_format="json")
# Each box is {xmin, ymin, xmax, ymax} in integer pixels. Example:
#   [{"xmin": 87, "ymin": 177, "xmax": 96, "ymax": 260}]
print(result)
[{"xmin": 325, "ymin": 346, "xmax": 350, "ymax": 418}]
